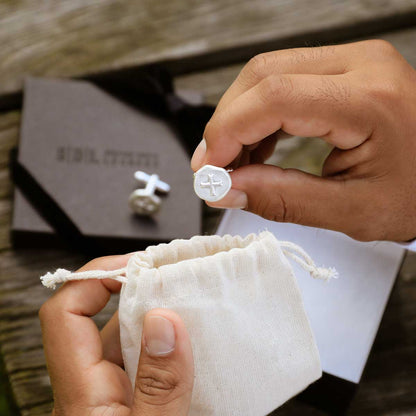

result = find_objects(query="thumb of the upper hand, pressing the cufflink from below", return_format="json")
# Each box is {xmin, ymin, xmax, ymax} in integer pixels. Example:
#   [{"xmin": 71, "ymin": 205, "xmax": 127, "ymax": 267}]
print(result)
[{"xmin": 208, "ymin": 164, "xmax": 360, "ymax": 239}]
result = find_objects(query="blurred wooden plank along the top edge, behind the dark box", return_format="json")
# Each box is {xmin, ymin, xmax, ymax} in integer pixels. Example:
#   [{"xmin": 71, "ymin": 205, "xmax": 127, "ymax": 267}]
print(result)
[{"xmin": 0, "ymin": 0, "xmax": 416, "ymax": 106}]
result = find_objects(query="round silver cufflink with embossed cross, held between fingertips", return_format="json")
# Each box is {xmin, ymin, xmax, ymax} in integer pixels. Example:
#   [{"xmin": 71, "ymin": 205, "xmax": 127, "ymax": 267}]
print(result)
[{"xmin": 194, "ymin": 165, "xmax": 231, "ymax": 202}]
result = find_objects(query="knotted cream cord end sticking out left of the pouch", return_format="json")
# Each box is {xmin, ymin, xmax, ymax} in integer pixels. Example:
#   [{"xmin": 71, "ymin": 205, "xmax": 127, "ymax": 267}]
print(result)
[{"xmin": 40, "ymin": 267, "xmax": 127, "ymax": 289}]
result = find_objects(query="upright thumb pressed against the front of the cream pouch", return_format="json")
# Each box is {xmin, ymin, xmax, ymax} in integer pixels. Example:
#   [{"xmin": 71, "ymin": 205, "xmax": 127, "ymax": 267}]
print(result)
[{"xmin": 132, "ymin": 309, "xmax": 194, "ymax": 416}]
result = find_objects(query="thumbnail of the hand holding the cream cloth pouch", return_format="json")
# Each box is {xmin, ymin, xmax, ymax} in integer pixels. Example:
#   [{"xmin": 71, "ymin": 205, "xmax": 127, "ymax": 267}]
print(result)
[{"xmin": 143, "ymin": 315, "xmax": 175, "ymax": 356}]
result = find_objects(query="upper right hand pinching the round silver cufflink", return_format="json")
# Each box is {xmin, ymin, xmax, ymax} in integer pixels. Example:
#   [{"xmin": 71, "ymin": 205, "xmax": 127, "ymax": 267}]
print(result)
[{"xmin": 192, "ymin": 40, "xmax": 416, "ymax": 241}]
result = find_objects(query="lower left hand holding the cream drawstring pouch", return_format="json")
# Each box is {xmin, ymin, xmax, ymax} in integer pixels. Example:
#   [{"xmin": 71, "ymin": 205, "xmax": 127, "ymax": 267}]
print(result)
[{"xmin": 39, "ymin": 256, "xmax": 194, "ymax": 416}]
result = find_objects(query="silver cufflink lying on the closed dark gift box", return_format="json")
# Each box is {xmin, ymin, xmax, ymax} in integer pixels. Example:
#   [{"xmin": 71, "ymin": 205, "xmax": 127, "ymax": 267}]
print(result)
[{"xmin": 129, "ymin": 170, "xmax": 170, "ymax": 215}]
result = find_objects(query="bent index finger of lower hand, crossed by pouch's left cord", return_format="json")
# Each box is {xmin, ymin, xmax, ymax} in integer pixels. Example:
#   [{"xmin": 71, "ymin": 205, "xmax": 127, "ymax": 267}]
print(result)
[{"xmin": 39, "ymin": 255, "xmax": 130, "ymax": 394}]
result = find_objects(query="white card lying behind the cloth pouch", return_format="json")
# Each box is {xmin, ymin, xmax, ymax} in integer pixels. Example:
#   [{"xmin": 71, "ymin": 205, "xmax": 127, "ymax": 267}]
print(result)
[{"xmin": 217, "ymin": 210, "xmax": 405, "ymax": 383}]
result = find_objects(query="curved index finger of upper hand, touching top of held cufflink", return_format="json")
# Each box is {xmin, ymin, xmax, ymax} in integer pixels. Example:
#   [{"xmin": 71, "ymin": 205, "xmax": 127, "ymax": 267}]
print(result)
[{"xmin": 197, "ymin": 74, "xmax": 375, "ymax": 170}]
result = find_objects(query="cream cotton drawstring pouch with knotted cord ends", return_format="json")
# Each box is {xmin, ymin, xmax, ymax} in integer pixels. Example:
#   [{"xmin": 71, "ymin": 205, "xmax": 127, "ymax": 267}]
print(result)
[{"xmin": 42, "ymin": 232, "xmax": 336, "ymax": 416}]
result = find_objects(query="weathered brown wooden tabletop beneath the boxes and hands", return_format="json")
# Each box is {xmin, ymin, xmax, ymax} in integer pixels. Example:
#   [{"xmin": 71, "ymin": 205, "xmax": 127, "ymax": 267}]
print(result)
[{"xmin": 0, "ymin": 0, "xmax": 416, "ymax": 416}]
